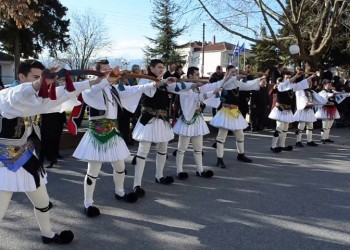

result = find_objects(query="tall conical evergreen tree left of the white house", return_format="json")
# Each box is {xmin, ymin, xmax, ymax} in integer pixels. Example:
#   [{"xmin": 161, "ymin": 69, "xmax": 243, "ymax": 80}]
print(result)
[{"xmin": 143, "ymin": 0, "xmax": 186, "ymax": 66}]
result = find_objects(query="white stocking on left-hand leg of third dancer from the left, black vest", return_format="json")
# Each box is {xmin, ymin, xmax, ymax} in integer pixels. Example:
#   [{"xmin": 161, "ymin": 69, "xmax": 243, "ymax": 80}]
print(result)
[{"xmin": 134, "ymin": 141, "xmax": 151, "ymax": 187}]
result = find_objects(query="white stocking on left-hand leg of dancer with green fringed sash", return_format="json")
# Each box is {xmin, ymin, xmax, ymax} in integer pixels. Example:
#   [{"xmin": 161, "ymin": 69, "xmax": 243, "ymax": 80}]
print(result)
[{"xmin": 84, "ymin": 162, "xmax": 102, "ymax": 208}]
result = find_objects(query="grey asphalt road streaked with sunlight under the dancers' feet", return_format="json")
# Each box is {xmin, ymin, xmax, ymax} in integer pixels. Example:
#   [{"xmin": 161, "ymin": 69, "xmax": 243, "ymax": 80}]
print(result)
[{"xmin": 0, "ymin": 128, "xmax": 350, "ymax": 250}]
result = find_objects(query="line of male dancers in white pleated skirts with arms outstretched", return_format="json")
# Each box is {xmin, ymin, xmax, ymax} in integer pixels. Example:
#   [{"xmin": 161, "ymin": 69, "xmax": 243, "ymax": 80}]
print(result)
[{"xmin": 0, "ymin": 59, "xmax": 348, "ymax": 244}]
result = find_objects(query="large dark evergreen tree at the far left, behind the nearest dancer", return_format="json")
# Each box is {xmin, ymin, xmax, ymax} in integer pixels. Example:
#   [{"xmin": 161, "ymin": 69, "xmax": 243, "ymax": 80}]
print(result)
[{"xmin": 0, "ymin": 0, "xmax": 69, "ymax": 75}]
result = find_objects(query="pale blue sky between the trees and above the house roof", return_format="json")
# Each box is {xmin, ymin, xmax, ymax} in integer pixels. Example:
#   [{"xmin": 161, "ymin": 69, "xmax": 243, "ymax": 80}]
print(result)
[{"xmin": 60, "ymin": 0, "xmax": 237, "ymax": 60}]
